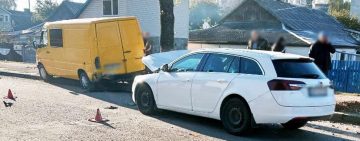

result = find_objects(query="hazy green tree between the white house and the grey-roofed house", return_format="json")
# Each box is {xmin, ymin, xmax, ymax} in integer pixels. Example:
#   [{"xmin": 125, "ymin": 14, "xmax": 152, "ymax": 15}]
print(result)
[{"xmin": 189, "ymin": 1, "xmax": 221, "ymax": 30}]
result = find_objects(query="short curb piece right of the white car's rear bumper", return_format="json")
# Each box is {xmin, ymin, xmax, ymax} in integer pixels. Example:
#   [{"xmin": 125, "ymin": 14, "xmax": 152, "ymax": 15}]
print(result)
[{"xmin": 330, "ymin": 112, "xmax": 360, "ymax": 125}]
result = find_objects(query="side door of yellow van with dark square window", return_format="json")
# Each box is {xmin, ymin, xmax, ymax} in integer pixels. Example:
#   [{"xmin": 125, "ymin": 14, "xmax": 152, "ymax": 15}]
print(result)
[{"xmin": 49, "ymin": 28, "xmax": 67, "ymax": 76}]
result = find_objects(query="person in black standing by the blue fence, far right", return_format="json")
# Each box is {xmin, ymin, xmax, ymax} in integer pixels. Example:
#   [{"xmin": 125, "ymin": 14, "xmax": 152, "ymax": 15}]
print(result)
[{"xmin": 309, "ymin": 31, "xmax": 336, "ymax": 74}]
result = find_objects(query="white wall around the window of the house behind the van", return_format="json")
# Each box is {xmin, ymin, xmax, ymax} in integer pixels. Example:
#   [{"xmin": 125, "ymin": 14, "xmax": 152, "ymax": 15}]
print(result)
[{"xmin": 79, "ymin": 0, "xmax": 189, "ymax": 38}]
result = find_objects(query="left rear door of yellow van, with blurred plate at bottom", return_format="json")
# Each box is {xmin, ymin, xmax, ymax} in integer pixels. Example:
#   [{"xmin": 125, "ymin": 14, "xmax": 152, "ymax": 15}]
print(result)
[{"xmin": 96, "ymin": 21, "xmax": 126, "ymax": 74}]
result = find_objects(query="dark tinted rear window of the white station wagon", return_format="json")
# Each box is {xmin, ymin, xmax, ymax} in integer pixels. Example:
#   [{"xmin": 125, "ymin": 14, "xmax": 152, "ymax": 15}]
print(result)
[{"xmin": 273, "ymin": 60, "xmax": 326, "ymax": 79}]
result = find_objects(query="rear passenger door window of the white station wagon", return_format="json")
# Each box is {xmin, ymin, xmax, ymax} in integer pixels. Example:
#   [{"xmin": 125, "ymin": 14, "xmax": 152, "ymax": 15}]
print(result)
[{"xmin": 203, "ymin": 54, "xmax": 234, "ymax": 72}]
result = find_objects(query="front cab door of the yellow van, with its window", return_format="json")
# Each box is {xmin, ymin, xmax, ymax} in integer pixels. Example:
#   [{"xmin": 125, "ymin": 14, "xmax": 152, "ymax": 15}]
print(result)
[{"xmin": 36, "ymin": 30, "xmax": 53, "ymax": 74}]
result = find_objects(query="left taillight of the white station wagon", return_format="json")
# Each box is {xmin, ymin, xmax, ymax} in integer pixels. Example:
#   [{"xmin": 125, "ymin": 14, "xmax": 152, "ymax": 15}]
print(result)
[{"xmin": 268, "ymin": 79, "xmax": 305, "ymax": 91}]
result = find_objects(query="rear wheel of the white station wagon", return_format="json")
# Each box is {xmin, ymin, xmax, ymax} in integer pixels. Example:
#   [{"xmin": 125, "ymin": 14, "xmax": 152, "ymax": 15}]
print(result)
[{"xmin": 221, "ymin": 98, "xmax": 251, "ymax": 135}]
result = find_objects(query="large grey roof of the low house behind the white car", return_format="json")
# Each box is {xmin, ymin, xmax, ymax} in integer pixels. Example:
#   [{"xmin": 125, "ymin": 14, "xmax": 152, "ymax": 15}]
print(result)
[{"xmin": 189, "ymin": 0, "xmax": 359, "ymax": 47}]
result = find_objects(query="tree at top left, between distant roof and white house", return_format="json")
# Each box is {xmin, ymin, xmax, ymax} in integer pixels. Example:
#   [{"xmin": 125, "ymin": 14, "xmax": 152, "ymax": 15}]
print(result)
[{"xmin": 32, "ymin": 0, "xmax": 59, "ymax": 23}]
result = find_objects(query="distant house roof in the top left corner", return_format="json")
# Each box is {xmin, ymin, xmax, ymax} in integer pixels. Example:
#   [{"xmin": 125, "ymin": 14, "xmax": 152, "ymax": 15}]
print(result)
[{"xmin": 7, "ymin": 10, "xmax": 35, "ymax": 31}]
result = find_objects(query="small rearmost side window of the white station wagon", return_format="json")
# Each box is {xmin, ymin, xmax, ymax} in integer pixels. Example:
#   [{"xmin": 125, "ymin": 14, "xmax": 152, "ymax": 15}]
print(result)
[{"xmin": 240, "ymin": 58, "xmax": 263, "ymax": 75}]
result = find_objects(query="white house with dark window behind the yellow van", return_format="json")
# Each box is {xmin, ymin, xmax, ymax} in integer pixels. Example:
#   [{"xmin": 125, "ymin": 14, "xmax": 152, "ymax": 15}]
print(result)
[{"xmin": 77, "ymin": 0, "xmax": 189, "ymax": 52}]
